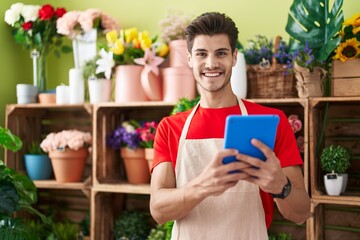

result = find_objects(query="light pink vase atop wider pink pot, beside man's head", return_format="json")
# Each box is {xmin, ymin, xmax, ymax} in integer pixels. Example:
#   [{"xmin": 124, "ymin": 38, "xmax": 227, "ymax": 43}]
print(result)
[{"xmin": 169, "ymin": 39, "xmax": 190, "ymax": 68}]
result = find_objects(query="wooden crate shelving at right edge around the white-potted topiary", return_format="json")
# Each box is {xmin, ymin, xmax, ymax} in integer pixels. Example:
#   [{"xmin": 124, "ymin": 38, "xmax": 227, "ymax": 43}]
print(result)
[{"xmin": 308, "ymin": 97, "xmax": 360, "ymax": 240}]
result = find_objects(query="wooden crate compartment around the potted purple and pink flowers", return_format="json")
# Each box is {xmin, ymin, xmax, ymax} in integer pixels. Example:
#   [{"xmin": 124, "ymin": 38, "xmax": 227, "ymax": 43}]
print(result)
[{"xmin": 93, "ymin": 102, "xmax": 174, "ymax": 186}]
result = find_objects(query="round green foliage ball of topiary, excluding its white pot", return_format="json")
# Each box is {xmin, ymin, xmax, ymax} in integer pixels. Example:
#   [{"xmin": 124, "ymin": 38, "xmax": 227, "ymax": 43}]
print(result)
[{"xmin": 320, "ymin": 145, "xmax": 351, "ymax": 174}]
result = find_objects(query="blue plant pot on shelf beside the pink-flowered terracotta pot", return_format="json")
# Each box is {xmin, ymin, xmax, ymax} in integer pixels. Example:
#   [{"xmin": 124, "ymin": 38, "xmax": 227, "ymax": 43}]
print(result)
[{"xmin": 24, "ymin": 154, "xmax": 53, "ymax": 180}]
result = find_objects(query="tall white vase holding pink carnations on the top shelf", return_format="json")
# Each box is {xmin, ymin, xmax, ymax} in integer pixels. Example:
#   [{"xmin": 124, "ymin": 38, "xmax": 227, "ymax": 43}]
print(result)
[{"xmin": 72, "ymin": 28, "xmax": 97, "ymax": 69}]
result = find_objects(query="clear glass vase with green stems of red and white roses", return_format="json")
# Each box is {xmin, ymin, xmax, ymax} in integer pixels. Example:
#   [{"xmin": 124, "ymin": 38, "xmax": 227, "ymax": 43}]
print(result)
[{"xmin": 31, "ymin": 49, "xmax": 46, "ymax": 93}]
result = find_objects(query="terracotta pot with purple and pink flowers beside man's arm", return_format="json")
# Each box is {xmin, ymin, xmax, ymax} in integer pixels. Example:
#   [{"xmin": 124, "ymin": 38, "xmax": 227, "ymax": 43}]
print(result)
[{"xmin": 106, "ymin": 120, "xmax": 153, "ymax": 184}]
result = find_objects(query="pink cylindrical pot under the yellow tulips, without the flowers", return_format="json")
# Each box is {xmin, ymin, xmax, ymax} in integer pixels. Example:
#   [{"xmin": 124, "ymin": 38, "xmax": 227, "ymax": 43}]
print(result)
[{"xmin": 115, "ymin": 65, "xmax": 148, "ymax": 102}]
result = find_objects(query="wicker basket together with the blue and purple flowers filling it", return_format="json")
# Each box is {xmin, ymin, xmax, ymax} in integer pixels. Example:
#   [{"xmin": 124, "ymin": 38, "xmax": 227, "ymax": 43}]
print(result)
[{"xmin": 244, "ymin": 35, "xmax": 297, "ymax": 98}]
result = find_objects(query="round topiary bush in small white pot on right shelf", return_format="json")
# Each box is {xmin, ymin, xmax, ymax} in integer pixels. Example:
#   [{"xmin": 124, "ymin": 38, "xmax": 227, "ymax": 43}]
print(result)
[{"xmin": 320, "ymin": 145, "xmax": 351, "ymax": 196}]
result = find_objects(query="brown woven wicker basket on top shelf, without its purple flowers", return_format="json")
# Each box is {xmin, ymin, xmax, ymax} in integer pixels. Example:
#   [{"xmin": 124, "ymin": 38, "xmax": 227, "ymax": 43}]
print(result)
[{"xmin": 246, "ymin": 37, "xmax": 297, "ymax": 98}]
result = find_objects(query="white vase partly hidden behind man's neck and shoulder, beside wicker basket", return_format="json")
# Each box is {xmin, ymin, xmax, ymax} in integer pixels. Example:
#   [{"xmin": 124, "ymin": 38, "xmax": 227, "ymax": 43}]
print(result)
[{"xmin": 230, "ymin": 52, "xmax": 247, "ymax": 98}]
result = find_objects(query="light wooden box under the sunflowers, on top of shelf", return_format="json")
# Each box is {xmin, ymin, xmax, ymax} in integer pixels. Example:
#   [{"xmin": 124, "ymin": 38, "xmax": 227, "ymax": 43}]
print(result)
[{"xmin": 331, "ymin": 59, "xmax": 360, "ymax": 97}]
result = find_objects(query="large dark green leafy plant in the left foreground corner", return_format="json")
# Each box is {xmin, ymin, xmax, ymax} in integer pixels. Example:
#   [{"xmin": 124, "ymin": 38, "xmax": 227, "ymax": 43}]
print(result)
[{"xmin": 0, "ymin": 127, "xmax": 49, "ymax": 240}]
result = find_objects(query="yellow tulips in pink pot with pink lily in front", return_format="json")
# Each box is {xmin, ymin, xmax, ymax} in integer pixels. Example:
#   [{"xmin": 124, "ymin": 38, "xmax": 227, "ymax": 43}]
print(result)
[{"xmin": 106, "ymin": 28, "xmax": 169, "ymax": 102}]
